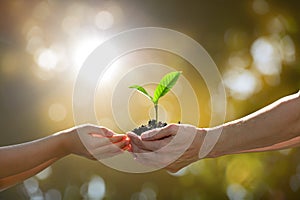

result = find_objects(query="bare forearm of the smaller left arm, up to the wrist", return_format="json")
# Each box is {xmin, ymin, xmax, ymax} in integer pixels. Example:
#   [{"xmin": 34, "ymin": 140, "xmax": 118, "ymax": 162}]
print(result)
[{"xmin": 0, "ymin": 134, "xmax": 67, "ymax": 177}]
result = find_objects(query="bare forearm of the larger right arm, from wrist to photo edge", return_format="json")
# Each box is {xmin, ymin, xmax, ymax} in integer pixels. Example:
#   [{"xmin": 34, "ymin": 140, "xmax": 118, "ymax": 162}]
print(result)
[{"xmin": 207, "ymin": 93, "xmax": 300, "ymax": 157}]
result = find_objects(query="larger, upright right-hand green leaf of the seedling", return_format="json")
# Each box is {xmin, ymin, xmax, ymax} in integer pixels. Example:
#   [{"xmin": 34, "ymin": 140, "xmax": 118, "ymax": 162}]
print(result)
[{"xmin": 152, "ymin": 72, "xmax": 181, "ymax": 104}]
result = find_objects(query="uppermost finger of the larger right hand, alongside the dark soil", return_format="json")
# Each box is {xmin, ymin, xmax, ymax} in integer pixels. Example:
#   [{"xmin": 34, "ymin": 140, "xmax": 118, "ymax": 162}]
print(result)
[{"xmin": 141, "ymin": 124, "xmax": 177, "ymax": 141}]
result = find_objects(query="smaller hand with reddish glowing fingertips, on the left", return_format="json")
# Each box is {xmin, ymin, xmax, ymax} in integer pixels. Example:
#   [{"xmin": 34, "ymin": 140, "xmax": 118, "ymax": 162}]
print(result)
[{"xmin": 59, "ymin": 124, "xmax": 129, "ymax": 160}]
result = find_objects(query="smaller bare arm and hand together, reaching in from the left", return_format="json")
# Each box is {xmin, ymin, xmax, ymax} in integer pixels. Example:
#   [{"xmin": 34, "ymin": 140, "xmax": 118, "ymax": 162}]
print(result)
[{"xmin": 0, "ymin": 124, "xmax": 129, "ymax": 191}]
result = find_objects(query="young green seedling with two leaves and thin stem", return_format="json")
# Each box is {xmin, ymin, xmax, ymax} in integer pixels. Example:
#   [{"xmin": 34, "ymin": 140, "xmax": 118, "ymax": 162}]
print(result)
[{"xmin": 129, "ymin": 72, "xmax": 181, "ymax": 125}]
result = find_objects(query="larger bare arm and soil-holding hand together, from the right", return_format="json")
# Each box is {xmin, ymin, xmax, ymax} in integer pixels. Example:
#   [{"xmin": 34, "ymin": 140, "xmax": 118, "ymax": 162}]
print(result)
[{"xmin": 128, "ymin": 92, "xmax": 300, "ymax": 172}]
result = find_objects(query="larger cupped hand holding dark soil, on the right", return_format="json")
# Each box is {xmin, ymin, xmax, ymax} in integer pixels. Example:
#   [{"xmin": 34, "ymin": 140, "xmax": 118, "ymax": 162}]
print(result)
[{"xmin": 127, "ymin": 124, "xmax": 206, "ymax": 172}]
